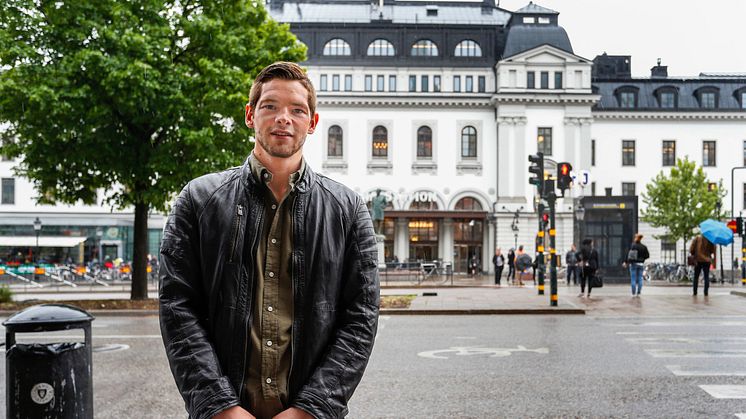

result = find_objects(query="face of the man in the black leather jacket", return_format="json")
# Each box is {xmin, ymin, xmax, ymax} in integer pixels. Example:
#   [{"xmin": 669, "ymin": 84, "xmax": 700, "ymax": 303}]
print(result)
[{"xmin": 246, "ymin": 79, "xmax": 319, "ymax": 158}]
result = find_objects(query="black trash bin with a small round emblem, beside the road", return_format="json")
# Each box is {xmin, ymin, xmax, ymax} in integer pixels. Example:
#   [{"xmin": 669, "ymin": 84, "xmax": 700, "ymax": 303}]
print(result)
[{"xmin": 3, "ymin": 304, "xmax": 94, "ymax": 419}]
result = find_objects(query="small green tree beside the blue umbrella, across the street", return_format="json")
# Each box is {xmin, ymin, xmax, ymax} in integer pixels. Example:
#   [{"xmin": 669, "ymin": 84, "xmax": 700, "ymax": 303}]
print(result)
[{"xmin": 641, "ymin": 158, "xmax": 725, "ymax": 249}]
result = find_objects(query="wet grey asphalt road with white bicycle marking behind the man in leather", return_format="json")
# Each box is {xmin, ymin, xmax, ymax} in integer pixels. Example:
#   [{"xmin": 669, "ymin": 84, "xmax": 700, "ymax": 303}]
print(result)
[{"xmin": 0, "ymin": 315, "xmax": 746, "ymax": 418}]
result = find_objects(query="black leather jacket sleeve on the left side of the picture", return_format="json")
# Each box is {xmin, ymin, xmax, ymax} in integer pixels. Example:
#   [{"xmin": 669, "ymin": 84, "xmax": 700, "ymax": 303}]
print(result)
[{"xmin": 159, "ymin": 185, "xmax": 239, "ymax": 419}]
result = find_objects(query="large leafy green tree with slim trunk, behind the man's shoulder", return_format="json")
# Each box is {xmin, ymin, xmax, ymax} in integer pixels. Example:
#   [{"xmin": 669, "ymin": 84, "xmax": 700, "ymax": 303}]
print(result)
[{"xmin": 0, "ymin": 0, "xmax": 306, "ymax": 299}]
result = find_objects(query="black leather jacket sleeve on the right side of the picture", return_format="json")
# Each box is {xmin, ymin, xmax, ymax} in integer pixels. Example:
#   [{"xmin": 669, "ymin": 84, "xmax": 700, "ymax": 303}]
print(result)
[{"xmin": 292, "ymin": 198, "xmax": 380, "ymax": 419}]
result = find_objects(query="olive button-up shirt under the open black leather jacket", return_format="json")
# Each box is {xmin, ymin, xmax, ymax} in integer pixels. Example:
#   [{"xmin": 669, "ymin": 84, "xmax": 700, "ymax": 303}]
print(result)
[{"xmin": 246, "ymin": 153, "xmax": 306, "ymax": 419}]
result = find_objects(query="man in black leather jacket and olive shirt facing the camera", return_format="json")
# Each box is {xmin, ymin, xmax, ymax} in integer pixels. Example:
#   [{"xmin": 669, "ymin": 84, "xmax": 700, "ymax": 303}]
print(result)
[{"xmin": 160, "ymin": 63, "xmax": 379, "ymax": 419}]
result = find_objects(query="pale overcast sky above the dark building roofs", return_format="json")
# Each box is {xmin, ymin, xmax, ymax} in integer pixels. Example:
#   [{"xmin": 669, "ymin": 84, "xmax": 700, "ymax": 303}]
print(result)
[{"xmin": 500, "ymin": 0, "xmax": 746, "ymax": 77}]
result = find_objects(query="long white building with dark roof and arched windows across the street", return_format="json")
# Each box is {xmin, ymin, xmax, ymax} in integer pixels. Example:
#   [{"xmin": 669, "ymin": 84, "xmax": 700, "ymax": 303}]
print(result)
[{"xmin": 0, "ymin": 0, "xmax": 746, "ymax": 278}]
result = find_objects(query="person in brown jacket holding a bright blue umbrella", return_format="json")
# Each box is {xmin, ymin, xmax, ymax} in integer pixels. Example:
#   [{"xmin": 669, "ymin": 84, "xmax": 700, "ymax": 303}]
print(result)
[{"xmin": 689, "ymin": 219, "xmax": 733, "ymax": 296}]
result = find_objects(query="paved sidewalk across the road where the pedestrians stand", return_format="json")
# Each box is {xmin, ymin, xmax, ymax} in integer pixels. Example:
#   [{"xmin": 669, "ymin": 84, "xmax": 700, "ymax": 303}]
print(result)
[{"xmin": 0, "ymin": 275, "xmax": 746, "ymax": 316}]
